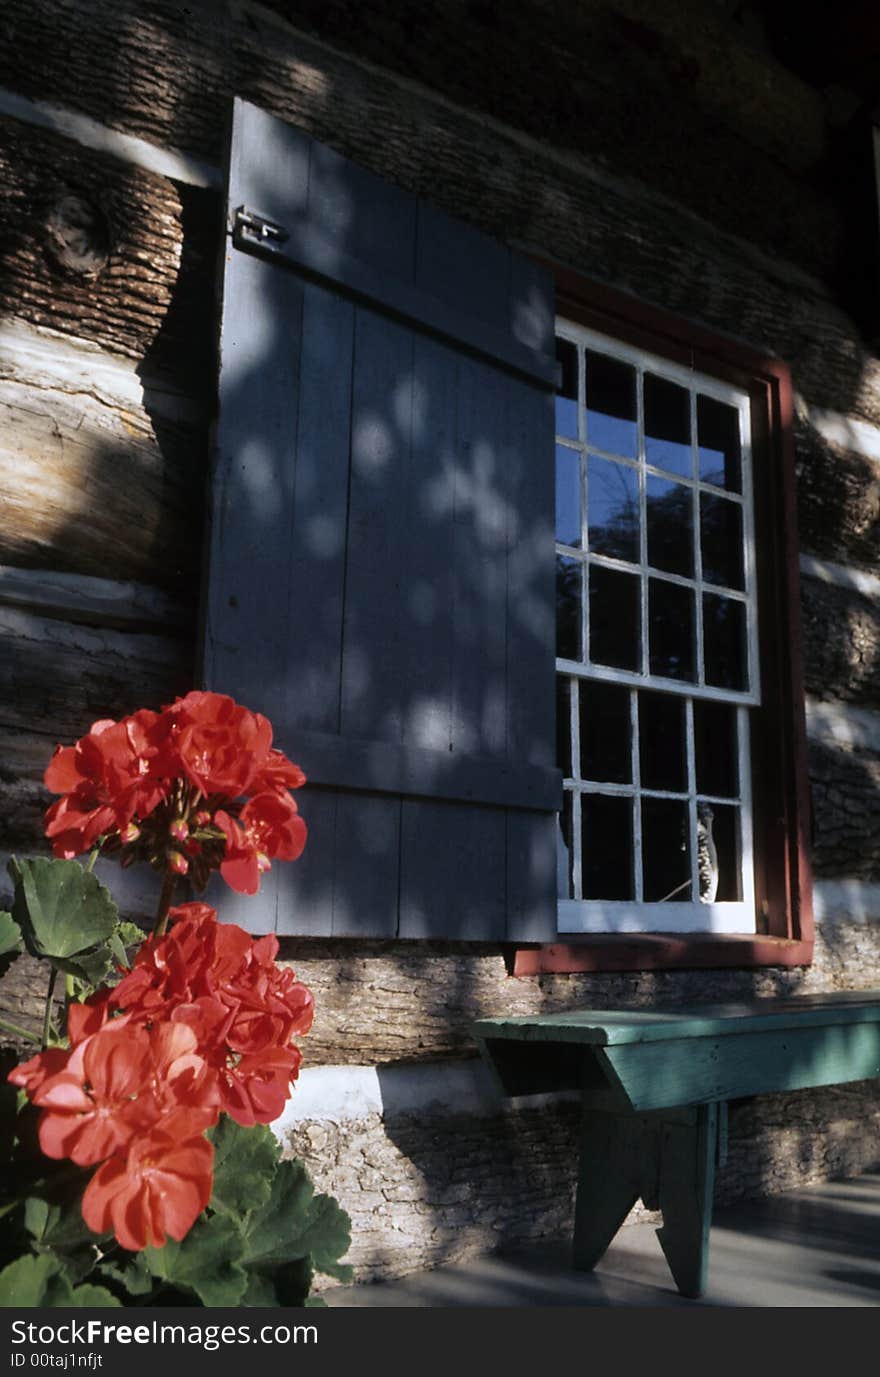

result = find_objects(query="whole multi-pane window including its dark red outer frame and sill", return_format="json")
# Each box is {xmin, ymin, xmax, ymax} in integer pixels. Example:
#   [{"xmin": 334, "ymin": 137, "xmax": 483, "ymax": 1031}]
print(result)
[{"xmin": 510, "ymin": 267, "xmax": 813, "ymax": 975}]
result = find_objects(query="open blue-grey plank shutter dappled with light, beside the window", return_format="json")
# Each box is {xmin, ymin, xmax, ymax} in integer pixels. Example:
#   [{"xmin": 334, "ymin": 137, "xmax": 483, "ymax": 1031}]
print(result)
[{"xmin": 202, "ymin": 101, "xmax": 561, "ymax": 940}]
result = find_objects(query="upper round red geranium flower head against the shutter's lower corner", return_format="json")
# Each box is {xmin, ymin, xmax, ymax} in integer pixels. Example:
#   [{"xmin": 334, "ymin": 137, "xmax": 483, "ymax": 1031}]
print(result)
[{"xmin": 44, "ymin": 690, "xmax": 306, "ymax": 894}]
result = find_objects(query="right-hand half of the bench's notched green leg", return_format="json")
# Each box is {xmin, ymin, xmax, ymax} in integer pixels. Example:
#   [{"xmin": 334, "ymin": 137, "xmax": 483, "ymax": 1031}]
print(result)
[{"xmin": 657, "ymin": 1104, "xmax": 717, "ymax": 1297}]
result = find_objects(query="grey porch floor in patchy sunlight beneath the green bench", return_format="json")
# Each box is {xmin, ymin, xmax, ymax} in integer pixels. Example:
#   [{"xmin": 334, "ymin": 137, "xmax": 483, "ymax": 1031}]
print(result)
[{"xmin": 324, "ymin": 1170, "xmax": 880, "ymax": 1308}]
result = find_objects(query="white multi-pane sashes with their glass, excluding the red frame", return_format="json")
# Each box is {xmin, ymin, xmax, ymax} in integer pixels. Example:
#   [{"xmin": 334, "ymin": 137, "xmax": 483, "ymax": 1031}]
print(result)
[{"xmin": 556, "ymin": 322, "xmax": 760, "ymax": 932}]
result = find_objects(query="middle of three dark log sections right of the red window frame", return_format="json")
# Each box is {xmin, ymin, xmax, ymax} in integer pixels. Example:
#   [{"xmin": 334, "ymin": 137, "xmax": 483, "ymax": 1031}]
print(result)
[{"xmin": 800, "ymin": 578, "xmax": 880, "ymax": 708}]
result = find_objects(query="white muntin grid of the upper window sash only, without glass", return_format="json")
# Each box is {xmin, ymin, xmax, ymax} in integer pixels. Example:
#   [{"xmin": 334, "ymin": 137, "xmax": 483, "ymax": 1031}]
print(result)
[{"xmin": 556, "ymin": 321, "xmax": 760, "ymax": 704}]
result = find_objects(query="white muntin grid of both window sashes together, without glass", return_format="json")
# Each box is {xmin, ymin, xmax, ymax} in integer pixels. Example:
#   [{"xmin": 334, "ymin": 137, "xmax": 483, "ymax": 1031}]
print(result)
[{"xmin": 556, "ymin": 322, "xmax": 760, "ymax": 934}]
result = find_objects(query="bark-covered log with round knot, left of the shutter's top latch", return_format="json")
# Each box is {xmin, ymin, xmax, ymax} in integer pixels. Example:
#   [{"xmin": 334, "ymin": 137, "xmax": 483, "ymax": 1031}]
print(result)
[{"xmin": 0, "ymin": 117, "xmax": 220, "ymax": 397}]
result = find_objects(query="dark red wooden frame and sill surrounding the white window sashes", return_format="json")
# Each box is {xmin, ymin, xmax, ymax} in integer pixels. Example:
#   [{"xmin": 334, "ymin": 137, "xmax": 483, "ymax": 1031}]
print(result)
[{"xmin": 508, "ymin": 263, "xmax": 814, "ymax": 976}]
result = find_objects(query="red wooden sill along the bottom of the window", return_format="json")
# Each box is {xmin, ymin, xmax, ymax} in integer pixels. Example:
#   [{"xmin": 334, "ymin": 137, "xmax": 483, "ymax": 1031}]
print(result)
[{"xmin": 508, "ymin": 932, "xmax": 813, "ymax": 976}]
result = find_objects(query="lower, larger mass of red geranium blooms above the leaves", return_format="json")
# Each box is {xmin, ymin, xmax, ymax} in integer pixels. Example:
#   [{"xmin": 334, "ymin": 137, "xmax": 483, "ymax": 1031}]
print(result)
[{"xmin": 10, "ymin": 903, "xmax": 314, "ymax": 1250}]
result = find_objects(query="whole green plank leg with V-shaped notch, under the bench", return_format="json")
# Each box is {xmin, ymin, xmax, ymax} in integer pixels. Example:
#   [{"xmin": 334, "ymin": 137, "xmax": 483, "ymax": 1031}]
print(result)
[{"xmin": 573, "ymin": 1104, "xmax": 717, "ymax": 1297}]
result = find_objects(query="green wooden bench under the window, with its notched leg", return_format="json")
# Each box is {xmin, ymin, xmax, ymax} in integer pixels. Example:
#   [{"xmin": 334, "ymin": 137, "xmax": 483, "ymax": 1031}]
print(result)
[{"xmin": 474, "ymin": 990, "xmax": 880, "ymax": 1296}]
